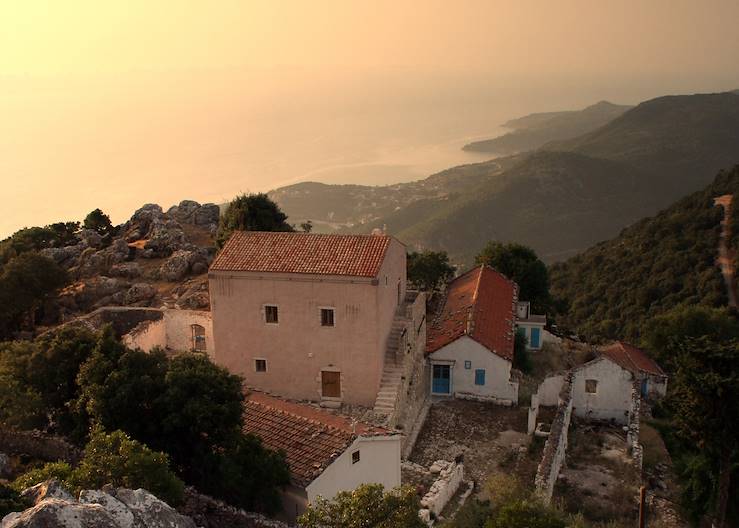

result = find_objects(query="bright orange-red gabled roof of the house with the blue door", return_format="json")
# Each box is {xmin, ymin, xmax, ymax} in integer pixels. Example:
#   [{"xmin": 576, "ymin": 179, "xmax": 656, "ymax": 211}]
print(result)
[{"xmin": 426, "ymin": 266, "xmax": 518, "ymax": 361}]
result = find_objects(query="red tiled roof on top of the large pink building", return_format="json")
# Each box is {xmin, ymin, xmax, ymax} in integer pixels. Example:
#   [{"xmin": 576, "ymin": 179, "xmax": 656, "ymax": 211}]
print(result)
[{"xmin": 210, "ymin": 231, "xmax": 391, "ymax": 277}]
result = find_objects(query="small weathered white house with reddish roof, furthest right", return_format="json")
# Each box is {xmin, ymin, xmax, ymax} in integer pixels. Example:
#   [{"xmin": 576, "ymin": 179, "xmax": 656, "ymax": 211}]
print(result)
[{"xmin": 537, "ymin": 342, "xmax": 667, "ymax": 425}]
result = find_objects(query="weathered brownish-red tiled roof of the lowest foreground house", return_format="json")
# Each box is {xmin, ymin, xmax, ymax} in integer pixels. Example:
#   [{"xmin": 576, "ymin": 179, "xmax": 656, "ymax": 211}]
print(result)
[{"xmin": 244, "ymin": 392, "xmax": 391, "ymax": 486}]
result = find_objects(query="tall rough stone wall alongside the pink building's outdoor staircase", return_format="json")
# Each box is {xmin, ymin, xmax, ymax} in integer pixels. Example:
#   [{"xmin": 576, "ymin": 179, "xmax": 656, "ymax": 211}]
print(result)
[{"xmin": 389, "ymin": 292, "xmax": 431, "ymax": 453}]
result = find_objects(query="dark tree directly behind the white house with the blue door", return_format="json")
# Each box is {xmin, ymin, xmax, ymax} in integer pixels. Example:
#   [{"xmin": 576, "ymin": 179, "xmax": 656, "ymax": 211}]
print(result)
[{"xmin": 475, "ymin": 241, "xmax": 550, "ymax": 312}]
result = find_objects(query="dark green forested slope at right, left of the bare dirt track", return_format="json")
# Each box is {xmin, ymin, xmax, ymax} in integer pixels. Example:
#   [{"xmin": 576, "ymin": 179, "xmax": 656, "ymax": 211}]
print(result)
[{"xmin": 550, "ymin": 166, "xmax": 739, "ymax": 341}]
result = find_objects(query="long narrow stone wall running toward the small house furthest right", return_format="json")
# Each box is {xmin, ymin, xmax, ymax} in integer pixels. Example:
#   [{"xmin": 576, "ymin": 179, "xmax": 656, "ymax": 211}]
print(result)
[{"xmin": 534, "ymin": 372, "xmax": 573, "ymax": 502}]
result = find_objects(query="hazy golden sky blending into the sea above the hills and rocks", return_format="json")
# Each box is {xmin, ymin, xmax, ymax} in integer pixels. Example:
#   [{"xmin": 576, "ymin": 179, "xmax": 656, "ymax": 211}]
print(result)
[{"xmin": 0, "ymin": 0, "xmax": 739, "ymax": 236}]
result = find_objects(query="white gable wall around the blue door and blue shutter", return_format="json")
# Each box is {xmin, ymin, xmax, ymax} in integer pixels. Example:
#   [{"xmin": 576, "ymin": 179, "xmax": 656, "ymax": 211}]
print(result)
[{"xmin": 429, "ymin": 336, "xmax": 518, "ymax": 403}]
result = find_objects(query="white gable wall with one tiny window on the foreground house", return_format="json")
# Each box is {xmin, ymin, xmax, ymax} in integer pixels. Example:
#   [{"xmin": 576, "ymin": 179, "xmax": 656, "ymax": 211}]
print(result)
[{"xmin": 306, "ymin": 435, "xmax": 401, "ymax": 502}]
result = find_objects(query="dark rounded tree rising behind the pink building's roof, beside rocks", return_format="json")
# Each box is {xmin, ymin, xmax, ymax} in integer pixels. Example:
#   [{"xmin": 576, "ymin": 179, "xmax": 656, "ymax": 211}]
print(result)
[{"xmin": 216, "ymin": 193, "xmax": 293, "ymax": 248}]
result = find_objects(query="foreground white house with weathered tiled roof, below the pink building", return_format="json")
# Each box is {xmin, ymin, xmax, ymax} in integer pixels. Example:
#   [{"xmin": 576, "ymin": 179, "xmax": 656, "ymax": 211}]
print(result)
[{"xmin": 244, "ymin": 392, "xmax": 401, "ymax": 521}]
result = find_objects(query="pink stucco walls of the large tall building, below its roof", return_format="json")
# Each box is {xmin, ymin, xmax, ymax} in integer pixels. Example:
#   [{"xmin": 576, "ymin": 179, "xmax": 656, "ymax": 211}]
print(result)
[{"xmin": 210, "ymin": 240, "xmax": 406, "ymax": 406}]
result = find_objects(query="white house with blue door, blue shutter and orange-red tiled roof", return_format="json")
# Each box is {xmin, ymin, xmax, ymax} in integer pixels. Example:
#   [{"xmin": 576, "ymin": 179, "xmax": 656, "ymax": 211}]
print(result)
[{"xmin": 426, "ymin": 266, "xmax": 518, "ymax": 403}]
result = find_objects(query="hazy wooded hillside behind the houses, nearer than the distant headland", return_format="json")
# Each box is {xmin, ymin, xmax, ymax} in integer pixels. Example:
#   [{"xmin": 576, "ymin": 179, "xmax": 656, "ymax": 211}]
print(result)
[{"xmin": 270, "ymin": 93, "xmax": 739, "ymax": 265}]
